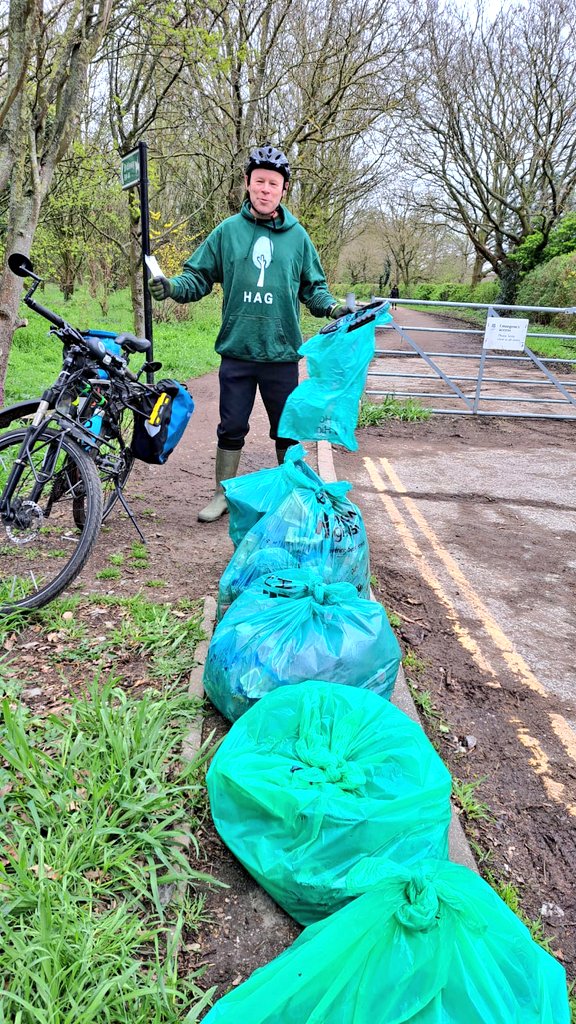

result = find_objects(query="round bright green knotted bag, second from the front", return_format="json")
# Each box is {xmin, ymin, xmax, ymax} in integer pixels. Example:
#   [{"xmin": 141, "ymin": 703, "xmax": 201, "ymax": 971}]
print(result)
[{"xmin": 203, "ymin": 682, "xmax": 451, "ymax": 925}]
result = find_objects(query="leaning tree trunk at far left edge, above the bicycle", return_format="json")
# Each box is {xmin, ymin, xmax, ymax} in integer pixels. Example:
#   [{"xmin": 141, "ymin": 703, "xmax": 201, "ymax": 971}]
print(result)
[{"xmin": 0, "ymin": 0, "xmax": 113, "ymax": 400}]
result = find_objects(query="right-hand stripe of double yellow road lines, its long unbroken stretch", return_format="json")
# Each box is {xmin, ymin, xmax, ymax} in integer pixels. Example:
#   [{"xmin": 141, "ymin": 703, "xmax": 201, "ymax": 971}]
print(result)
[{"xmin": 380, "ymin": 459, "xmax": 547, "ymax": 696}]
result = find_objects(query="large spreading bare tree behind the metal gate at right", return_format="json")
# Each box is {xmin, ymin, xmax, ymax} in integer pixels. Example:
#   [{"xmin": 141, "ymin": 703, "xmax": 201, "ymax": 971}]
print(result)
[{"xmin": 399, "ymin": 0, "xmax": 576, "ymax": 298}]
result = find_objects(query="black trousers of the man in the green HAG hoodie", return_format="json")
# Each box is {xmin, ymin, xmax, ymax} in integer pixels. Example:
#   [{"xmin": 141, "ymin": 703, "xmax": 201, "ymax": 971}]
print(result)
[{"xmin": 217, "ymin": 355, "xmax": 298, "ymax": 452}]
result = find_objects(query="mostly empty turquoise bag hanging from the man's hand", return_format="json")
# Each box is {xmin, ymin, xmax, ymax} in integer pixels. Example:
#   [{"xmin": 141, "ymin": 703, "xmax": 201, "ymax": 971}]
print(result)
[{"xmin": 278, "ymin": 301, "xmax": 392, "ymax": 452}]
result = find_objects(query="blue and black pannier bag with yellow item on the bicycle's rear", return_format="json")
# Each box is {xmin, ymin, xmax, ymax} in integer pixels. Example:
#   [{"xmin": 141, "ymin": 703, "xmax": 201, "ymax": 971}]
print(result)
[{"xmin": 130, "ymin": 380, "xmax": 194, "ymax": 465}]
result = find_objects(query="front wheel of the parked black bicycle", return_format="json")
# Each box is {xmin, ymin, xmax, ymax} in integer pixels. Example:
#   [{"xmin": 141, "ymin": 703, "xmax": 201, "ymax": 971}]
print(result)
[{"xmin": 0, "ymin": 430, "xmax": 102, "ymax": 612}]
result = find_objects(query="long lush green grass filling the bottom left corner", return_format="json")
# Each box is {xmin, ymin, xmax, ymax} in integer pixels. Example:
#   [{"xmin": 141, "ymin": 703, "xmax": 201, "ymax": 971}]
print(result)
[{"xmin": 0, "ymin": 682, "xmax": 212, "ymax": 1024}]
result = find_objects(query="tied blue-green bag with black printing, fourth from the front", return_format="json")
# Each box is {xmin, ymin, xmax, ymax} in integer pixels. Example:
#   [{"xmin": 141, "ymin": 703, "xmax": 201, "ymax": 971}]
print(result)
[{"xmin": 218, "ymin": 469, "xmax": 370, "ymax": 611}]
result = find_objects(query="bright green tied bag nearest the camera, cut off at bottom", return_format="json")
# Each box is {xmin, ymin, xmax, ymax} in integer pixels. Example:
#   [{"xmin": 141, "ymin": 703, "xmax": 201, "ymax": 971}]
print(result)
[{"xmin": 204, "ymin": 861, "xmax": 570, "ymax": 1024}]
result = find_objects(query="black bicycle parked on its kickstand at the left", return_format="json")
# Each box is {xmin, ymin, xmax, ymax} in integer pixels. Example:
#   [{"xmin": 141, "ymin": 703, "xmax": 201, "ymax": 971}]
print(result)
[{"xmin": 0, "ymin": 253, "xmax": 166, "ymax": 612}]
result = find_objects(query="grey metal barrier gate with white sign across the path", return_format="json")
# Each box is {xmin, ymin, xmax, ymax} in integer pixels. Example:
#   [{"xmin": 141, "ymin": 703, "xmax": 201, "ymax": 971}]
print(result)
[{"xmin": 365, "ymin": 299, "xmax": 576, "ymax": 420}]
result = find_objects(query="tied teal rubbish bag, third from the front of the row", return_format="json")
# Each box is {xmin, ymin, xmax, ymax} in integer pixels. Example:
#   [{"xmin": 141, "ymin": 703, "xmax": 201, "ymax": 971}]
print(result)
[{"xmin": 204, "ymin": 569, "xmax": 401, "ymax": 722}]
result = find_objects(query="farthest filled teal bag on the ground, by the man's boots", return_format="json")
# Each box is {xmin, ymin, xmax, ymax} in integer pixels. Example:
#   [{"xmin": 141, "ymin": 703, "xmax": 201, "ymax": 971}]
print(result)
[{"xmin": 222, "ymin": 444, "xmax": 323, "ymax": 548}]
